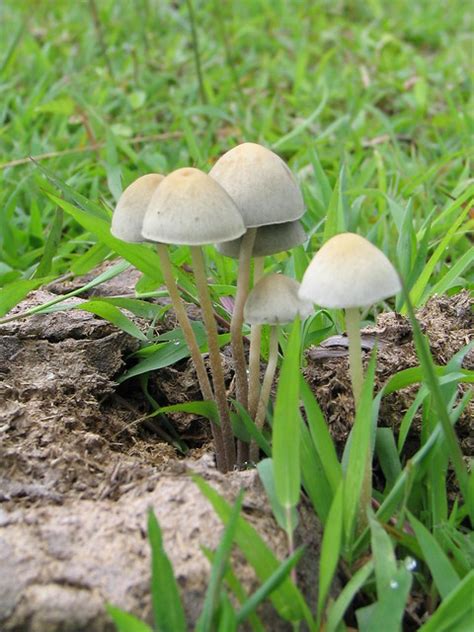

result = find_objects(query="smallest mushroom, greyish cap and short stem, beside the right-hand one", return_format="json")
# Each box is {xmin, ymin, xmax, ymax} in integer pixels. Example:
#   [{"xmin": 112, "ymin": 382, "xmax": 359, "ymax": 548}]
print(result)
[{"xmin": 244, "ymin": 274, "xmax": 312, "ymax": 461}]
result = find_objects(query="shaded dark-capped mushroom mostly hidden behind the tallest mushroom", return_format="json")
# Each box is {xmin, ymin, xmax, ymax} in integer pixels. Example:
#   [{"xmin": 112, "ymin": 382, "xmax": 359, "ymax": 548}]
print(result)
[{"xmin": 216, "ymin": 220, "xmax": 307, "ymax": 418}]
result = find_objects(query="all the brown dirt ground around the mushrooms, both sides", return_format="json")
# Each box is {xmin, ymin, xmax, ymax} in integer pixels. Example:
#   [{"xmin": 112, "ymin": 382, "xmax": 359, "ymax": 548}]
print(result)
[{"xmin": 0, "ymin": 270, "xmax": 474, "ymax": 632}]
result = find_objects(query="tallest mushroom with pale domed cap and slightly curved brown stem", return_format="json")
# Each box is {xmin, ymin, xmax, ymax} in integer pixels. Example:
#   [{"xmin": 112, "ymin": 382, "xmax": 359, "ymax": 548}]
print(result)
[{"xmin": 209, "ymin": 143, "xmax": 304, "ymax": 408}]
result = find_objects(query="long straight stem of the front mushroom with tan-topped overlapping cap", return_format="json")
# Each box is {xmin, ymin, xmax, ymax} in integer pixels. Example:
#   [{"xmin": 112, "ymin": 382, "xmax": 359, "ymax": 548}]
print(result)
[{"xmin": 190, "ymin": 246, "xmax": 236, "ymax": 470}]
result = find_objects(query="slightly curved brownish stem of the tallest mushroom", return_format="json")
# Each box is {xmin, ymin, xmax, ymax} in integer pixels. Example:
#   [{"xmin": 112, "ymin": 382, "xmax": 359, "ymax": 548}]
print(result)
[{"xmin": 230, "ymin": 228, "xmax": 257, "ymax": 408}]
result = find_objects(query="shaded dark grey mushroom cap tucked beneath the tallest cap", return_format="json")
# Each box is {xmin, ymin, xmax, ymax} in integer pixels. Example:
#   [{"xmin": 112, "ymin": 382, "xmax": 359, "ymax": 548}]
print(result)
[{"xmin": 216, "ymin": 220, "xmax": 307, "ymax": 259}]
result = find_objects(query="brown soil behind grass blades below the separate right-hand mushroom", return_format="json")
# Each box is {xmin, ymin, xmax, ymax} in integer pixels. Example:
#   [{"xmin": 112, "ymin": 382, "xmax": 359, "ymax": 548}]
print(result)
[{"xmin": 305, "ymin": 291, "xmax": 474, "ymax": 454}]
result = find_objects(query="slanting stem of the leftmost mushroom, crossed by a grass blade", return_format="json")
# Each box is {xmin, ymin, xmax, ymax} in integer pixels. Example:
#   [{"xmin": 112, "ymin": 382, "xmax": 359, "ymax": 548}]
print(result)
[{"xmin": 156, "ymin": 243, "xmax": 228, "ymax": 472}]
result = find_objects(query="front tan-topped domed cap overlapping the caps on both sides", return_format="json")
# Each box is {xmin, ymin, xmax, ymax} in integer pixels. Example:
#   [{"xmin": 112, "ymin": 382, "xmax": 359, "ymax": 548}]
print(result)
[{"xmin": 142, "ymin": 167, "xmax": 245, "ymax": 246}]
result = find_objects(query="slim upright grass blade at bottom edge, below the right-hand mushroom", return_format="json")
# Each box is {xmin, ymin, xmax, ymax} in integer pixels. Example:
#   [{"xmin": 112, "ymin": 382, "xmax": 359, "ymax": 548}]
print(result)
[{"xmin": 318, "ymin": 481, "xmax": 344, "ymax": 621}]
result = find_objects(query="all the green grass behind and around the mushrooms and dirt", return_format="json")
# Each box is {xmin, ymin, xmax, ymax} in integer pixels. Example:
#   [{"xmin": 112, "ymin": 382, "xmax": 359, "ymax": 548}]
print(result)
[{"xmin": 0, "ymin": 0, "xmax": 474, "ymax": 631}]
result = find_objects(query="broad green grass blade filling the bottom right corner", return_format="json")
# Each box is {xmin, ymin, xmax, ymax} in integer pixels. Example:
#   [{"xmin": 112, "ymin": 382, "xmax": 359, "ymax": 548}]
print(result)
[{"xmin": 418, "ymin": 570, "xmax": 474, "ymax": 632}]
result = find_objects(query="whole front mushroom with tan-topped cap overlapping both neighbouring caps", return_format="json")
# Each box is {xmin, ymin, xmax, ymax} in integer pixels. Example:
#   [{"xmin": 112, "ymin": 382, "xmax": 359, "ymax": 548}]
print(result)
[{"xmin": 142, "ymin": 168, "xmax": 245, "ymax": 470}]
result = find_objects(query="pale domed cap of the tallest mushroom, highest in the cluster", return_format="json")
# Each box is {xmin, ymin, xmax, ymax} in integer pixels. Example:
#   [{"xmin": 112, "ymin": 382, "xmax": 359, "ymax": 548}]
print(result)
[{"xmin": 209, "ymin": 143, "xmax": 304, "ymax": 228}]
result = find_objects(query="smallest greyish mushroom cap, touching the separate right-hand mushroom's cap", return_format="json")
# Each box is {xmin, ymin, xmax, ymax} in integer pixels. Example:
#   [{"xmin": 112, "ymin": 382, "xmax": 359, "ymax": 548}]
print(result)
[{"xmin": 244, "ymin": 274, "xmax": 313, "ymax": 325}]
